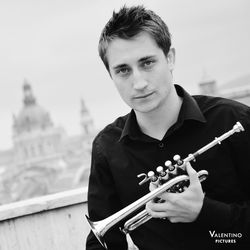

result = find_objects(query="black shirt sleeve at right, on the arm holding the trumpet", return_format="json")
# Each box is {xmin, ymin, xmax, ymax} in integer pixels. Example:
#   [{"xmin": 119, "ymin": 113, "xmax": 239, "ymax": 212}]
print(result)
[{"xmin": 195, "ymin": 109, "xmax": 250, "ymax": 241}]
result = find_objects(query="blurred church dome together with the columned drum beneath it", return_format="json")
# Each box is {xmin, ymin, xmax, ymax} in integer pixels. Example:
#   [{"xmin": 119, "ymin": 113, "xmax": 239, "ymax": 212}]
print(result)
[{"xmin": 13, "ymin": 82, "xmax": 65, "ymax": 166}]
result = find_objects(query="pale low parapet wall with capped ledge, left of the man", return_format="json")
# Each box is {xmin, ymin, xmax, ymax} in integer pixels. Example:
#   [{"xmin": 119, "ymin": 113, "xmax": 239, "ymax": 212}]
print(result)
[{"xmin": 0, "ymin": 188, "xmax": 136, "ymax": 250}]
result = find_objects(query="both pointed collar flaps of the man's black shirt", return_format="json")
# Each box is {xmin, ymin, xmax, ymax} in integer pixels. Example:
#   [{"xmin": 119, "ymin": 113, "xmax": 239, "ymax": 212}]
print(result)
[{"xmin": 119, "ymin": 84, "xmax": 206, "ymax": 141}]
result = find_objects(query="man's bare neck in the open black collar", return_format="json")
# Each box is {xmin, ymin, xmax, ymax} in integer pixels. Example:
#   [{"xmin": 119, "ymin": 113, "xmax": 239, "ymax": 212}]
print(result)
[{"xmin": 135, "ymin": 87, "xmax": 182, "ymax": 140}]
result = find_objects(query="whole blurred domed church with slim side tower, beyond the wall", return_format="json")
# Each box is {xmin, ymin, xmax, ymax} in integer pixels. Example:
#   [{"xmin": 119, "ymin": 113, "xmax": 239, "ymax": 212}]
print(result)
[{"xmin": 0, "ymin": 81, "xmax": 97, "ymax": 204}]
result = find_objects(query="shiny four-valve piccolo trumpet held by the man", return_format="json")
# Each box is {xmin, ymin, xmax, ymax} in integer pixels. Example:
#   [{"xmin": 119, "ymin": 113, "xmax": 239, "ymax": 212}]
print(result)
[{"xmin": 86, "ymin": 122, "xmax": 244, "ymax": 249}]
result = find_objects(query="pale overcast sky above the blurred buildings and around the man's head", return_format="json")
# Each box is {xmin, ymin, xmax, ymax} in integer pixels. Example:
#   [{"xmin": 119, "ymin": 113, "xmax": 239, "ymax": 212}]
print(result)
[{"xmin": 0, "ymin": 0, "xmax": 250, "ymax": 150}]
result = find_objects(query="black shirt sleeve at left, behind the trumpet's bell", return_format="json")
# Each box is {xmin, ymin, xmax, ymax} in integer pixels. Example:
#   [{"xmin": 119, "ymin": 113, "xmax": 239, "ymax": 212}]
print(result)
[{"xmin": 86, "ymin": 138, "xmax": 128, "ymax": 250}]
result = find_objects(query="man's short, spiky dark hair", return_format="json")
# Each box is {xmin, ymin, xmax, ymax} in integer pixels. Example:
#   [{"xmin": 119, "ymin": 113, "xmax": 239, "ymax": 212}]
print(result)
[{"xmin": 98, "ymin": 5, "xmax": 171, "ymax": 71}]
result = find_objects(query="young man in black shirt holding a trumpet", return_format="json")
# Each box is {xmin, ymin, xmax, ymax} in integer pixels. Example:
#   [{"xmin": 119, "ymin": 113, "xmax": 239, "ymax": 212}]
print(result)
[{"xmin": 86, "ymin": 6, "xmax": 250, "ymax": 250}]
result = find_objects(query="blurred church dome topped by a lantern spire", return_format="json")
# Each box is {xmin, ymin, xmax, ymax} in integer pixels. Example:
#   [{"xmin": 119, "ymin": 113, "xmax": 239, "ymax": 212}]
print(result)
[{"xmin": 13, "ymin": 82, "xmax": 52, "ymax": 135}]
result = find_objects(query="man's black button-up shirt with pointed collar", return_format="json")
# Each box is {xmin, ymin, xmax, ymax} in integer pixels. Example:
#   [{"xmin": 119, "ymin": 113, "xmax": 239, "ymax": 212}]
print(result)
[{"xmin": 86, "ymin": 85, "xmax": 250, "ymax": 250}]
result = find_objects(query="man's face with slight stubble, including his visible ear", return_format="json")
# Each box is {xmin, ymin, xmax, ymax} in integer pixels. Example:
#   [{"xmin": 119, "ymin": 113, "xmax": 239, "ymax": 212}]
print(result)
[{"xmin": 107, "ymin": 32, "xmax": 174, "ymax": 113}]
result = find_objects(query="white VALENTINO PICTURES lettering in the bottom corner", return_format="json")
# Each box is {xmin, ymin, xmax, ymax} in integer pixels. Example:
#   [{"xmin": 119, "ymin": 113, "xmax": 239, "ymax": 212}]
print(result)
[{"xmin": 208, "ymin": 230, "xmax": 242, "ymax": 244}]
